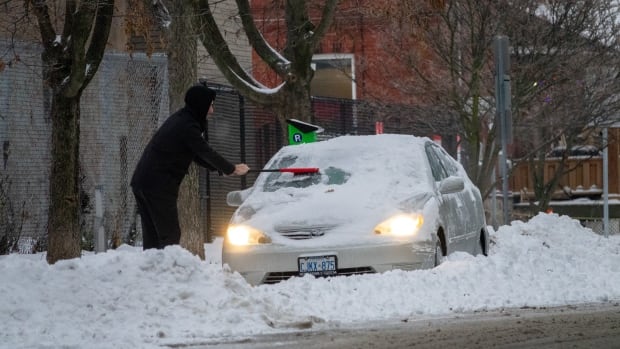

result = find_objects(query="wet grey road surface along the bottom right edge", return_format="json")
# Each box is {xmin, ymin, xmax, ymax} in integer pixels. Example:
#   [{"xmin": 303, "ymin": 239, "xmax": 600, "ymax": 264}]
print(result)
[{"xmin": 171, "ymin": 302, "xmax": 620, "ymax": 349}]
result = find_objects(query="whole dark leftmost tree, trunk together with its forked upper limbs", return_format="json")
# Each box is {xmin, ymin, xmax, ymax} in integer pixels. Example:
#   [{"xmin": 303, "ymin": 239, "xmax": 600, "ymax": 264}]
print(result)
[{"xmin": 18, "ymin": 0, "xmax": 114, "ymax": 263}]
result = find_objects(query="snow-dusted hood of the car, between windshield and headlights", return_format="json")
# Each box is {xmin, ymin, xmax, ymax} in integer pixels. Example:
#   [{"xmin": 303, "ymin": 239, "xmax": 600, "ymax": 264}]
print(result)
[{"xmin": 232, "ymin": 187, "xmax": 432, "ymax": 245}]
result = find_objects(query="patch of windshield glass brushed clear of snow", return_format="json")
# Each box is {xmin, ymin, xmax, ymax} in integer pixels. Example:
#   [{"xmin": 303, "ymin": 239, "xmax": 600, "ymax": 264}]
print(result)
[{"xmin": 263, "ymin": 155, "xmax": 351, "ymax": 192}]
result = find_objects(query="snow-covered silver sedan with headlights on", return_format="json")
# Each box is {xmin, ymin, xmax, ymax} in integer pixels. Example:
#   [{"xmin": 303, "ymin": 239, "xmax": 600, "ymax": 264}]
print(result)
[{"xmin": 222, "ymin": 134, "xmax": 489, "ymax": 285}]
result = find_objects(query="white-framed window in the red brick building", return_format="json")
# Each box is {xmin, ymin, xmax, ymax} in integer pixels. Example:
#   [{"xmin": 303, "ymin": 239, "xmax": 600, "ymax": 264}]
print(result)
[{"xmin": 310, "ymin": 53, "xmax": 355, "ymax": 99}]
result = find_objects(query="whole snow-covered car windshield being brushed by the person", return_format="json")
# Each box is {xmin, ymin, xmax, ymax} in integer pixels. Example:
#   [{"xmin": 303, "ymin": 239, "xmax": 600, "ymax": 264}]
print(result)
[{"xmin": 251, "ymin": 135, "xmax": 433, "ymax": 200}]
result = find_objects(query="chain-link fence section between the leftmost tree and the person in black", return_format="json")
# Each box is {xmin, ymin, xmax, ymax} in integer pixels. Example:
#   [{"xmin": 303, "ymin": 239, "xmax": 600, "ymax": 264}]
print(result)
[{"xmin": 80, "ymin": 54, "xmax": 169, "ymax": 249}]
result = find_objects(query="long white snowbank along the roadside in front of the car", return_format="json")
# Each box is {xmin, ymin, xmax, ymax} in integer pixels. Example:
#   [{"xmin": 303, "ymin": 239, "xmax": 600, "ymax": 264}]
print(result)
[{"xmin": 0, "ymin": 214, "xmax": 620, "ymax": 349}]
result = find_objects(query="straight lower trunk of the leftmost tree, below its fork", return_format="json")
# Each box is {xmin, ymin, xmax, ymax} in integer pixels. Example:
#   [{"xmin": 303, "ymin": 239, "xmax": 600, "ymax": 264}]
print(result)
[{"xmin": 47, "ymin": 94, "xmax": 81, "ymax": 264}]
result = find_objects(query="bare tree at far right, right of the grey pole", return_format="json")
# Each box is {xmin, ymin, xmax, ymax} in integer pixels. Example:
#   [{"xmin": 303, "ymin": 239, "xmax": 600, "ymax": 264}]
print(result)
[{"xmin": 506, "ymin": 1, "xmax": 620, "ymax": 211}]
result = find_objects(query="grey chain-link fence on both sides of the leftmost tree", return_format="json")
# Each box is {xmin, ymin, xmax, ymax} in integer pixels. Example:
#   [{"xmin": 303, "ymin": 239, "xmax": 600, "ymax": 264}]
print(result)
[{"xmin": 0, "ymin": 41, "xmax": 168, "ymax": 253}]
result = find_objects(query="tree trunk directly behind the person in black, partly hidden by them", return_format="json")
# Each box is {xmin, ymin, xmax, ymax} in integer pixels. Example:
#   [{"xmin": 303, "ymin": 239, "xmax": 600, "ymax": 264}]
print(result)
[{"xmin": 166, "ymin": 1, "xmax": 206, "ymax": 259}]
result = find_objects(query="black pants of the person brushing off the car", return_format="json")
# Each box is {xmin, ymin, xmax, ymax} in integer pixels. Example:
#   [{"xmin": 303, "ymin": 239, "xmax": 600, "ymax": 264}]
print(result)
[{"xmin": 132, "ymin": 188, "xmax": 181, "ymax": 250}]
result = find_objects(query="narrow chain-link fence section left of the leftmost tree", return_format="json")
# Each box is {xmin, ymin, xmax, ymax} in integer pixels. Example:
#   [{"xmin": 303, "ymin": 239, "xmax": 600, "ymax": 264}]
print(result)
[{"xmin": 0, "ymin": 38, "xmax": 50, "ymax": 250}]
